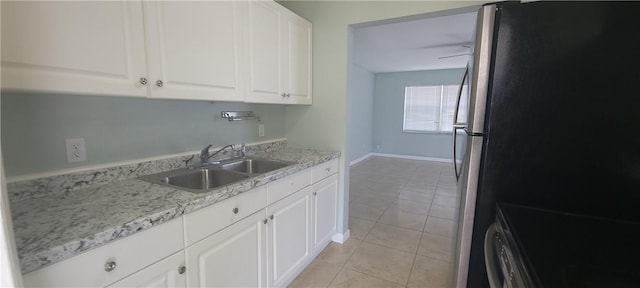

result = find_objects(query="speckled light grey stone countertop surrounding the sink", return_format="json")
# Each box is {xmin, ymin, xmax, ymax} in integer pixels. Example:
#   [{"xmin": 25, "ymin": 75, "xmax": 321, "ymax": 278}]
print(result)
[{"xmin": 11, "ymin": 147, "xmax": 340, "ymax": 273}]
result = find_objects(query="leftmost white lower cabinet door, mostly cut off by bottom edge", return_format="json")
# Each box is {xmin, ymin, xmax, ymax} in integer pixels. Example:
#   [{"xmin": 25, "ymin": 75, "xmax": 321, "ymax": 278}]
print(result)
[{"xmin": 109, "ymin": 251, "xmax": 187, "ymax": 288}]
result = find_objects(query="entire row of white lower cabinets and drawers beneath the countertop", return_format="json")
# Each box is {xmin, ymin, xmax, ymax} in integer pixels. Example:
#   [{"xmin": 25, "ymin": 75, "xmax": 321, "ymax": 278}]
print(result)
[{"xmin": 23, "ymin": 161, "xmax": 338, "ymax": 287}]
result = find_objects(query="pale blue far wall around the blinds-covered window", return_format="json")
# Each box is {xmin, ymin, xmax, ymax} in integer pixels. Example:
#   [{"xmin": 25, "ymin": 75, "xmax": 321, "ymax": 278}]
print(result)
[{"xmin": 373, "ymin": 69, "xmax": 464, "ymax": 159}]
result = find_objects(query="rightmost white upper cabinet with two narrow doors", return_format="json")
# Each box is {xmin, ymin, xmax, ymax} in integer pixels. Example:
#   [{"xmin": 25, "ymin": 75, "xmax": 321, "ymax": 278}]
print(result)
[{"xmin": 245, "ymin": 1, "xmax": 312, "ymax": 104}]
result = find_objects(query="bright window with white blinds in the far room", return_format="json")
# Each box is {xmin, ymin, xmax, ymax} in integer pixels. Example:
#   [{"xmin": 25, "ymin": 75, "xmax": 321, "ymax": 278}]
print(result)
[{"xmin": 402, "ymin": 85, "xmax": 468, "ymax": 133}]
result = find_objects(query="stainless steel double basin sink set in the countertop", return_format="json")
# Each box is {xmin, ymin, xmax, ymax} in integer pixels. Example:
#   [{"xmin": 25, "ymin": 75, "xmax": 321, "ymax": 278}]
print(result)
[{"xmin": 138, "ymin": 157, "xmax": 295, "ymax": 193}]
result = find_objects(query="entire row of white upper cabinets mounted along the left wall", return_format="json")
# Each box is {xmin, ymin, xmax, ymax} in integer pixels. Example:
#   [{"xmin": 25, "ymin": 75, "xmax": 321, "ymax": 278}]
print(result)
[{"xmin": 1, "ymin": 0, "xmax": 312, "ymax": 105}]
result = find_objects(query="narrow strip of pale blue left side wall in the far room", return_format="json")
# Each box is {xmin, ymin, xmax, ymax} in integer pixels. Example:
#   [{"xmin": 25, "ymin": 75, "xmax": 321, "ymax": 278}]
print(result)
[{"xmin": 347, "ymin": 65, "xmax": 375, "ymax": 161}]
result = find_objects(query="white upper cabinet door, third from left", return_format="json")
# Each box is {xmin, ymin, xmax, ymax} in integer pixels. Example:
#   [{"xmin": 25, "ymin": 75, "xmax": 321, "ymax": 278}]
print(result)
[{"xmin": 245, "ymin": 1, "xmax": 285, "ymax": 103}]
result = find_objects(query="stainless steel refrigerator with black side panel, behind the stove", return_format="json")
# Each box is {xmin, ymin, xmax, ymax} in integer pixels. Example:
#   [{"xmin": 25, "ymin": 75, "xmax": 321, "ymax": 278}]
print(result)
[{"xmin": 453, "ymin": 1, "xmax": 640, "ymax": 288}]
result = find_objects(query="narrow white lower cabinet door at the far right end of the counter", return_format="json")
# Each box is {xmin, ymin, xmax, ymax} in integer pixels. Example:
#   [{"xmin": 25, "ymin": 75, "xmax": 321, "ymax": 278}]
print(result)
[{"xmin": 313, "ymin": 174, "xmax": 338, "ymax": 252}]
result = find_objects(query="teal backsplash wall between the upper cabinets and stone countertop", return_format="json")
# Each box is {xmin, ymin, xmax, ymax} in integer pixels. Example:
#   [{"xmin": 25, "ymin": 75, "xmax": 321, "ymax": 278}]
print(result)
[{"xmin": 0, "ymin": 92, "xmax": 285, "ymax": 177}]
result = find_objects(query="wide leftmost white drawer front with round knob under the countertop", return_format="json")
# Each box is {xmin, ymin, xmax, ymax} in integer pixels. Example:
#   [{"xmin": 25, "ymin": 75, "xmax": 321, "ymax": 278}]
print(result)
[{"xmin": 22, "ymin": 218, "xmax": 184, "ymax": 287}]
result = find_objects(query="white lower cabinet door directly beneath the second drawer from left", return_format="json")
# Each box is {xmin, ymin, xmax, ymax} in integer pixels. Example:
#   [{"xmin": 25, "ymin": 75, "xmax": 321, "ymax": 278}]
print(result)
[{"xmin": 186, "ymin": 210, "xmax": 267, "ymax": 287}]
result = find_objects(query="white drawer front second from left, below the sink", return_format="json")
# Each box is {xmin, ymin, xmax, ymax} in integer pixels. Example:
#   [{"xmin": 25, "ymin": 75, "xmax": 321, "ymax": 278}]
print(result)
[{"xmin": 184, "ymin": 187, "xmax": 267, "ymax": 246}]
